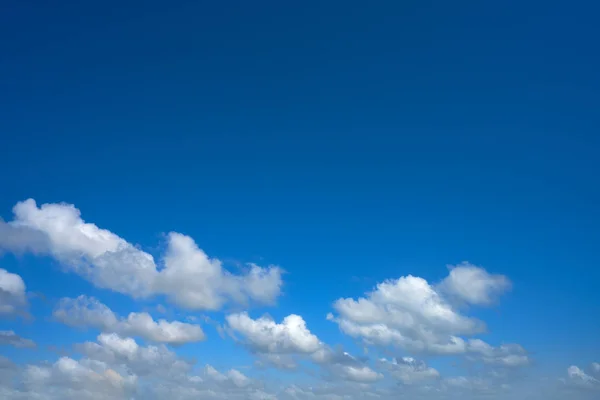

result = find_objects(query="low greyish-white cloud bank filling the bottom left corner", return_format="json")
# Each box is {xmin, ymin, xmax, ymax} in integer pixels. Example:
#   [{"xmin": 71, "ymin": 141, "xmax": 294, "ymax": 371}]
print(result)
[{"xmin": 0, "ymin": 334, "xmax": 277, "ymax": 400}]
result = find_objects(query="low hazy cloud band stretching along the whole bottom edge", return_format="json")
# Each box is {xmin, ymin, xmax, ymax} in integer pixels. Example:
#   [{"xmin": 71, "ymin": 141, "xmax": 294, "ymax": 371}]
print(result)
[{"xmin": 0, "ymin": 334, "xmax": 584, "ymax": 400}]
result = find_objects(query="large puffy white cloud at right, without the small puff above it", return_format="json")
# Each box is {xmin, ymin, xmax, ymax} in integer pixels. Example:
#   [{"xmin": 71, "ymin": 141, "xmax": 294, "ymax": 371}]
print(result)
[{"xmin": 329, "ymin": 275, "xmax": 485, "ymax": 354}]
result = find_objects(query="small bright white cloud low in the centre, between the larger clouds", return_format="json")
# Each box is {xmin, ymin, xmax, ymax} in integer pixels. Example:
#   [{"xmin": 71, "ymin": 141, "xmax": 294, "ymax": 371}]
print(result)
[{"xmin": 226, "ymin": 312, "xmax": 322, "ymax": 353}]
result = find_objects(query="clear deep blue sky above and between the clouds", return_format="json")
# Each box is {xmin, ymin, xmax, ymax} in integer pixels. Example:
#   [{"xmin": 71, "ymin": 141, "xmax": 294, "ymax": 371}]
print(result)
[{"xmin": 0, "ymin": 0, "xmax": 600, "ymax": 382}]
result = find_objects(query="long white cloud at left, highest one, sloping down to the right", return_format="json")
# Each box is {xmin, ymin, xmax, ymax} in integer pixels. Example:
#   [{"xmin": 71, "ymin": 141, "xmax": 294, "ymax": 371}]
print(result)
[{"xmin": 0, "ymin": 199, "xmax": 282, "ymax": 310}]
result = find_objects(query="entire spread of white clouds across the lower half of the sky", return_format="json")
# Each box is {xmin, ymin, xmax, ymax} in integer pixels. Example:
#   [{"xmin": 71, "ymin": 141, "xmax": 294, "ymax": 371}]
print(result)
[{"xmin": 0, "ymin": 200, "xmax": 600, "ymax": 400}]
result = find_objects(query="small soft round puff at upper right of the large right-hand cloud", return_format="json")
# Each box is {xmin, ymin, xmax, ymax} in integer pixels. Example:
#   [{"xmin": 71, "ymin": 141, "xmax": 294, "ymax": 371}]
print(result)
[{"xmin": 439, "ymin": 262, "xmax": 511, "ymax": 305}]
